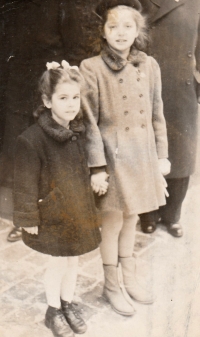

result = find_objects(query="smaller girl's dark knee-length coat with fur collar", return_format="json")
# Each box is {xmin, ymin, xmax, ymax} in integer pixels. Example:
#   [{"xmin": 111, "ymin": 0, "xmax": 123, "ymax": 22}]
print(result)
[{"xmin": 13, "ymin": 111, "xmax": 100, "ymax": 256}]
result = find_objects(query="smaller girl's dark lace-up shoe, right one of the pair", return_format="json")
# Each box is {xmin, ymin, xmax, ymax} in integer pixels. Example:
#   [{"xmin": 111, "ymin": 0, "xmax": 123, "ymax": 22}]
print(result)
[{"xmin": 61, "ymin": 300, "xmax": 87, "ymax": 334}]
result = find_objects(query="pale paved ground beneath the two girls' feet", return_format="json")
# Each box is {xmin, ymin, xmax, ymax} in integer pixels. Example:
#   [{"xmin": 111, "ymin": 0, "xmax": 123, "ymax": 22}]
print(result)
[{"xmin": 0, "ymin": 129, "xmax": 200, "ymax": 337}]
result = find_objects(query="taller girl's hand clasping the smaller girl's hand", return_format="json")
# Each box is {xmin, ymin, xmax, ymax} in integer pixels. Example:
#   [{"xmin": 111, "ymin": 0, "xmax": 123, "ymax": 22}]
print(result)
[{"xmin": 91, "ymin": 172, "xmax": 109, "ymax": 196}]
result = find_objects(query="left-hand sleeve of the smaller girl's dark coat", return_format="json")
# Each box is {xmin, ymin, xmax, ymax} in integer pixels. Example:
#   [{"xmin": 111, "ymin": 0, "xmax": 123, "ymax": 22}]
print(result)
[{"xmin": 13, "ymin": 136, "xmax": 40, "ymax": 227}]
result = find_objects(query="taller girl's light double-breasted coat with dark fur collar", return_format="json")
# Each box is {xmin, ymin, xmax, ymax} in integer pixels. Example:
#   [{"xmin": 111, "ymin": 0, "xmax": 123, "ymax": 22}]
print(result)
[{"xmin": 80, "ymin": 45, "xmax": 168, "ymax": 213}]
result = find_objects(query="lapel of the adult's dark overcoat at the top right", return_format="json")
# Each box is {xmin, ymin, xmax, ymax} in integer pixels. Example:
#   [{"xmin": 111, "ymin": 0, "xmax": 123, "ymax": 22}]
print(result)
[{"xmin": 150, "ymin": 0, "xmax": 187, "ymax": 22}]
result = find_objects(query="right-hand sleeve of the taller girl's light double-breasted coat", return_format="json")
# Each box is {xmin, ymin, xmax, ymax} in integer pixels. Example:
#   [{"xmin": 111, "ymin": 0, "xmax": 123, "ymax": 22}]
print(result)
[{"xmin": 151, "ymin": 57, "xmax": 168, "ymax": 159}]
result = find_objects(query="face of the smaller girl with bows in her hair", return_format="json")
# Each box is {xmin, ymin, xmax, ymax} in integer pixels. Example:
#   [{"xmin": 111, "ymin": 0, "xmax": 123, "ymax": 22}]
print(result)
[{"xmin": 44, "ymin": 82, "xmax": 80, "ymax": 127}]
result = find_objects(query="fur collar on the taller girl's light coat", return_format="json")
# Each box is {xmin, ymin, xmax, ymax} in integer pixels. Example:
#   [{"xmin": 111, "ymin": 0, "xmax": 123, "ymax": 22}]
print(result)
[{"xmin": 101, "ymin": 43, "xmax": 147, "ymax": 71}]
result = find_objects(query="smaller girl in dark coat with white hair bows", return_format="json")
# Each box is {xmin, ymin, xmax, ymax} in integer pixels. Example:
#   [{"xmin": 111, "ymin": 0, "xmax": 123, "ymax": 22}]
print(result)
[{"xmin": 14, "ymin": 61, "xmax": 101, "ymax": 337}]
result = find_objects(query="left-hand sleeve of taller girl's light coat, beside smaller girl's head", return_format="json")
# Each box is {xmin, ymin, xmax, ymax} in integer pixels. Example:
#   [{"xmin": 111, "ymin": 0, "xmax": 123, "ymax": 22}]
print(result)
[{"xmin": 80, "ymin": 60, "xmax": 106, "ymax": 167}]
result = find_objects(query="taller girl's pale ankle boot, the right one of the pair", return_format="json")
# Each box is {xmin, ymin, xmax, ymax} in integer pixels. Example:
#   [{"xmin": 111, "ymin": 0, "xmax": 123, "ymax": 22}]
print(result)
[{"xmin": 119, "ymin": 257, "xmax": 153, "ymax": 304}]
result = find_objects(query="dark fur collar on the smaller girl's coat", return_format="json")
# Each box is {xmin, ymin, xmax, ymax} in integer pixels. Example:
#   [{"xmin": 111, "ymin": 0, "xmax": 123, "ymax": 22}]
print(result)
[{"xmin": 38, "ymin": 109, "xmax": 85, "ymax": 142}]
